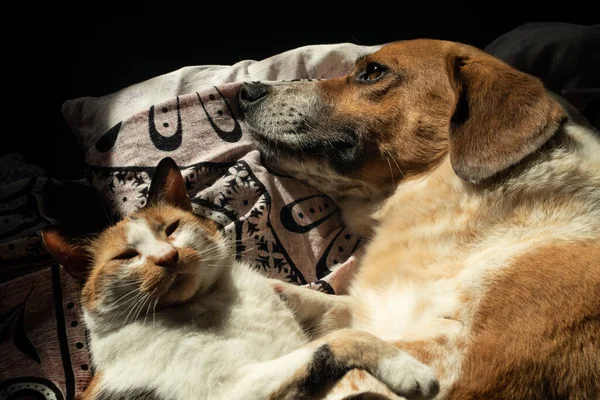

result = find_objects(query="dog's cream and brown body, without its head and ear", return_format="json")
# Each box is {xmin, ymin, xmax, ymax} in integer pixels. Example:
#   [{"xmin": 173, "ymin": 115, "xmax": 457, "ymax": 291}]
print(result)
[{"xmin": 353, "ymin": 124, "xmax": 600, "ymax": 399}]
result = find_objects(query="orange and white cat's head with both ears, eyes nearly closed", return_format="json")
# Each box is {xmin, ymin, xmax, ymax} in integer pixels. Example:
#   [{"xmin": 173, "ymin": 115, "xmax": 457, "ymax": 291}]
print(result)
[{"xmin": 43, "ymin": 158, "xmax": 229, "ymax": 318}]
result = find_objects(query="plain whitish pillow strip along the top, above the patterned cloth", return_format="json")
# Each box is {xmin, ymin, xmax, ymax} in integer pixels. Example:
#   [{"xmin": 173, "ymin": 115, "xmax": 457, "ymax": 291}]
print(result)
[{"xmin": 62, "ymin": 43, "xmax": 381, "ymax": 151}]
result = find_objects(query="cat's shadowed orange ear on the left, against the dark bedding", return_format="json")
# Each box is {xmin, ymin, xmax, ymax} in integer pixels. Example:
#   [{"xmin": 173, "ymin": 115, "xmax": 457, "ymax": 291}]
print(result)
[{"xmin": 42, "ymin": 225, "xmax": 91, "ymax": 279}]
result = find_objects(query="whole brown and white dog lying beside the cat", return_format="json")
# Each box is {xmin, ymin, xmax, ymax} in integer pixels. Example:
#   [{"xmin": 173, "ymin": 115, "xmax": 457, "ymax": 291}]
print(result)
[{"xmin": 240, "ymin": 40, "xmax": 600, "ymax": 399}]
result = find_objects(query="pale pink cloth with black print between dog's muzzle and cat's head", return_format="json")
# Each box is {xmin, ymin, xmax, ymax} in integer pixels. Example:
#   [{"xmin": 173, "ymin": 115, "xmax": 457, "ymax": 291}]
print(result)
[{"xmin": 86, "ymin": 83, "xmax": 360, "ymax": 293}]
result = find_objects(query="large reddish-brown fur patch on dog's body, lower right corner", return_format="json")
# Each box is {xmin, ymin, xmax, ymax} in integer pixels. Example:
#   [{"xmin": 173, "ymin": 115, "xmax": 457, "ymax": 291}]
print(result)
[{"xmin": 449, "ymin": 241, "xmax": 600, "ymax": 399}]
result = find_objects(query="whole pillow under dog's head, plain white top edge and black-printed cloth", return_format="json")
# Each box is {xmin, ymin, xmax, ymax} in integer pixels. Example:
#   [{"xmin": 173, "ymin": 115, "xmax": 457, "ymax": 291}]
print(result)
[{"xmin": 63, "ymin": 44, "xmax": 378, "ymax": 293}]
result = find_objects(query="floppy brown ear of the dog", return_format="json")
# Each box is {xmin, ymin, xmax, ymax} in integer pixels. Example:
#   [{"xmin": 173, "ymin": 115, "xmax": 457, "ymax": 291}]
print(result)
[{"xmin": 446, "ymin": 50, "xmax": 566, "ymax": 182}]
